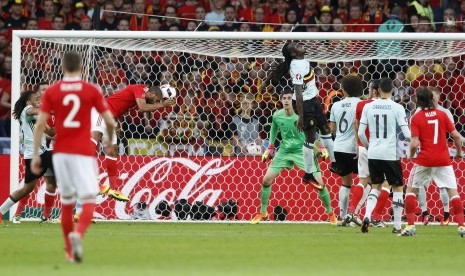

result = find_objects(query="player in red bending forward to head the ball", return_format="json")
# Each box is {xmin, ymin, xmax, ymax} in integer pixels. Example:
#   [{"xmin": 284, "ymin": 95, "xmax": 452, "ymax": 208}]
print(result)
[{"xmin": 92, "ymin": 84, "xmax": 176, "ymax": 201}]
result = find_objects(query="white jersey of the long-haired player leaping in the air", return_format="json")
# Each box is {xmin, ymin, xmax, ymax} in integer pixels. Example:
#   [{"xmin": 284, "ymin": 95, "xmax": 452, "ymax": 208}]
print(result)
[{"xmin": 289, "ymin": 59, "xmax": 318, "ymax": 101}]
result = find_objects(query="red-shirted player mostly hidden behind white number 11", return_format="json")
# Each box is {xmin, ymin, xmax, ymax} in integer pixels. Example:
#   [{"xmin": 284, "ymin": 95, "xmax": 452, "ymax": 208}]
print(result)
[{"xmin": 346, "ymin": 80, "xmax": 390, "ymax": 227}]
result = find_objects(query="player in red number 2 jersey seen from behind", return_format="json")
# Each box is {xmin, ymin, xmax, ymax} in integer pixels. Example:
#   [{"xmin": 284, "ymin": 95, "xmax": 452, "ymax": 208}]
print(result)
[{"xmin": 31, "ymin": 52, "xmax": 114, "ymax": 262}]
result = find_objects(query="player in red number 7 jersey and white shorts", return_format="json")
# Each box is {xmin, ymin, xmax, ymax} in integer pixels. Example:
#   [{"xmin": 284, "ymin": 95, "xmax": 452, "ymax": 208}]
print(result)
[{"xmin": 399, "ymin": 87, "xmax": 465, "ymax": 238}]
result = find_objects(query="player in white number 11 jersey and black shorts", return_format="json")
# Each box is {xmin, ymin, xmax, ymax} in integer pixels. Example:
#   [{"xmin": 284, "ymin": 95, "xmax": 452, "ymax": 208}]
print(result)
[{"xmin": 358, "ymin": 78, "xmax": 410, "ymax": 233}]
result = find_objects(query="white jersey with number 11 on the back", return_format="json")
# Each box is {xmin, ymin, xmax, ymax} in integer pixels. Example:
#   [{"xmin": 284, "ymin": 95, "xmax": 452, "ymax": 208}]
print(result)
[{"xmin": 360, "ymin": 99, "xmax": 408, "ymax": 160}]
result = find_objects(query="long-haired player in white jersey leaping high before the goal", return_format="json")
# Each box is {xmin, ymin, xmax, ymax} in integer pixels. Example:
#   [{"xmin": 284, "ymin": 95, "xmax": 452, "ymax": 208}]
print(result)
[{"xmin": 265, "ymin": 42, "xmax": 339, "ymax": 188}]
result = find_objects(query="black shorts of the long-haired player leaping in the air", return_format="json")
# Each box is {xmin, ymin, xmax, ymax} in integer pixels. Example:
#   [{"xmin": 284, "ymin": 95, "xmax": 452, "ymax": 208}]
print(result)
[{"xmin": 292, "ymin": 97, "xmax": 328, "ymax": 130}]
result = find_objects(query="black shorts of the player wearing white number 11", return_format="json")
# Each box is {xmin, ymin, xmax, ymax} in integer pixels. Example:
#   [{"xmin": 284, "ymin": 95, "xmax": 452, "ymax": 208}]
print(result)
[{"xmin": 368, "ymin": 159, "xmax": 404, "ymax": 187}]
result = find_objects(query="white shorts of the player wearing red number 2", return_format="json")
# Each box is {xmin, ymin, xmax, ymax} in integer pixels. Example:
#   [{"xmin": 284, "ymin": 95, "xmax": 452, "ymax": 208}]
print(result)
[{"xmin": 52, "ymin": 153, "xmax": 99, "ymax": 203}]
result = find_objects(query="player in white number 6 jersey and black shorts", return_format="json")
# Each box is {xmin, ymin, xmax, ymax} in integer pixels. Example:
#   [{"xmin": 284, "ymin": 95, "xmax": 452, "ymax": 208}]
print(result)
[{"xmin": 329, "ymin": 75, "xmax": 363, "ymax": 226}]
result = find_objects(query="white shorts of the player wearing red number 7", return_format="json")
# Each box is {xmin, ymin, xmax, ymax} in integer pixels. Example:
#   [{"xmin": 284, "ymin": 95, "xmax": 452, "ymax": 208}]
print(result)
[{"xmin": 407, "ymin": 164, "xmax": 457, "ymax": 189}]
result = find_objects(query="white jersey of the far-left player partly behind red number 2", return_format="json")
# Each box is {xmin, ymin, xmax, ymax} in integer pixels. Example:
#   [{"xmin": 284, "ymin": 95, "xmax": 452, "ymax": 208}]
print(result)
[{"xmin": 20, "ymin": 105, "xmax": 47, "ymax": 159}]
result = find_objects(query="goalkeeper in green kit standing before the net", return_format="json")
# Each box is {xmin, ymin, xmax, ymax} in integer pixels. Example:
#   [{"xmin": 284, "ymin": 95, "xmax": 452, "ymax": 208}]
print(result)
[{"xmin": 251, "ymin": 89, "xmax": 337, "ymax": 225}]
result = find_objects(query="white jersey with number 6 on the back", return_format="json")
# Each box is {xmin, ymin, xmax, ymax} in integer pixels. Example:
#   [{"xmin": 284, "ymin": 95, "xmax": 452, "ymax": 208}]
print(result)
[{"xmin": 329, "ymin": 97, "xmax": 360, "ymax": 153}]
